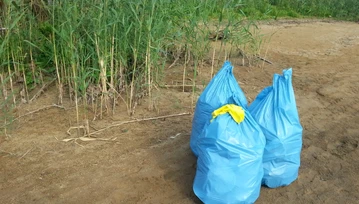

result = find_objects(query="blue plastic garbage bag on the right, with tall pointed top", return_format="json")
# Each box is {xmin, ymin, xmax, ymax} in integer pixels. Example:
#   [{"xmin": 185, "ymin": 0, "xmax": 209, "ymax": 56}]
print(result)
[{"xmin": 249, "ymin": 69, "xmax": 303, "ymax": 188}]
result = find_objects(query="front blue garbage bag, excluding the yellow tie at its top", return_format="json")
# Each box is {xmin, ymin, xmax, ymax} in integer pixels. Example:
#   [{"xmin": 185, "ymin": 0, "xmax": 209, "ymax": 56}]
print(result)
[{"xmin": 193, "ymin": 104, "xmax": 265, "ymax": 204}]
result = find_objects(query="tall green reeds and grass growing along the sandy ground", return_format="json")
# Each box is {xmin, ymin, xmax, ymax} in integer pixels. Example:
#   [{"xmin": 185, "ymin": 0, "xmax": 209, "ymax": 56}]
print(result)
[{"xmin": 0, "ymin": 0, "xmax": 359, "ymax": 130}]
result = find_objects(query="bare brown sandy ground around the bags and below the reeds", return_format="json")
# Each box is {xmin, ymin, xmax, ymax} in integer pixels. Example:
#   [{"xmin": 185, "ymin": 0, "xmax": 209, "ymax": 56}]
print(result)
[{"xmin": 0, "ymin": 21, "xmax": 359, "ymax": 204}]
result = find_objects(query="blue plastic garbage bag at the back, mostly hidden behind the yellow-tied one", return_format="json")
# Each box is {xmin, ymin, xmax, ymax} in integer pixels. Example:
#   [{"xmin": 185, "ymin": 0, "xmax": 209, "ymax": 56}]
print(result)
[{"xmin": 190, "ymin": 62, "xmax": 247, "ymax": 156}]
